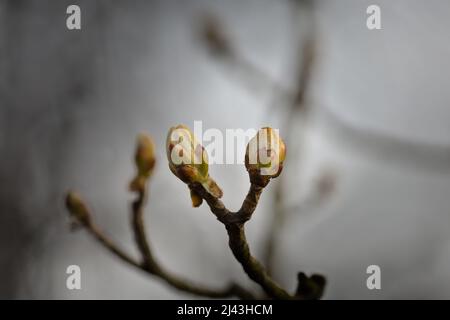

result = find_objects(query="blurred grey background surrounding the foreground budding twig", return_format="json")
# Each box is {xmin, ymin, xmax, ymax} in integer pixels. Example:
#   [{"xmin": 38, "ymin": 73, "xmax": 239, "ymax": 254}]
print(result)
[{"xmin": 0, "ymin": 0, "xmax": 450, "ymax": 299}]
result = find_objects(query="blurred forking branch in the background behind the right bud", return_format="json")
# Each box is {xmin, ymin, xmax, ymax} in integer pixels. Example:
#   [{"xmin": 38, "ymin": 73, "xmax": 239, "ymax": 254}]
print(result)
[{"xmin": 198, "ymin": 0, "xmax": 450, "ymax": 288}]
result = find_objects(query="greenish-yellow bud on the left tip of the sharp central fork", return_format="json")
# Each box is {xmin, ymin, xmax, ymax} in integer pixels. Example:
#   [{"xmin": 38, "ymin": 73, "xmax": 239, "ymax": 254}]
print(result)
[{"xmin": 166, "ymin": 125, "xmax": 223, "ymax": 202}]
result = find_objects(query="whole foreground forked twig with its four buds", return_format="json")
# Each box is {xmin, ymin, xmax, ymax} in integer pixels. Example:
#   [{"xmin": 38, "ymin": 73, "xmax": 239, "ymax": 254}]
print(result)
[{"xmin": 66, "ymin": 126, "xmax": 325, "ymax": 299}]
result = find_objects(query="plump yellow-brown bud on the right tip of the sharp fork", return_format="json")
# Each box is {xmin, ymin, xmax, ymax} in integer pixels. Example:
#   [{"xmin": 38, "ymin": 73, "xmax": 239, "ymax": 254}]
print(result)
[{"xmin": 245, "ymin": 127, "xmax": 286, "ymax": 187}]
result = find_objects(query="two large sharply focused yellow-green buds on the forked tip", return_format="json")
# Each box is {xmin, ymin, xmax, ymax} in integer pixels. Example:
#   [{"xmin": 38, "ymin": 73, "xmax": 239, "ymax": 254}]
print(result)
[{"xmin": 166, "ymin": 125, "xmax": 286, "ymax": 207}]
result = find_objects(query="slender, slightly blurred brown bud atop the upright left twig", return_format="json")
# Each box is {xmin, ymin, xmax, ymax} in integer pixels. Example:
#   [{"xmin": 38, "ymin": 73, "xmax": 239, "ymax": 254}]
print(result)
[{"xmin": 130, "ymin": 133, "xmax": 156, "ymax": 191}]
